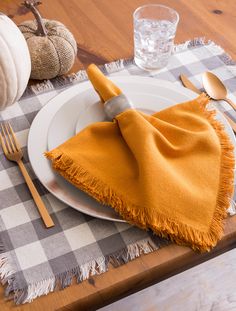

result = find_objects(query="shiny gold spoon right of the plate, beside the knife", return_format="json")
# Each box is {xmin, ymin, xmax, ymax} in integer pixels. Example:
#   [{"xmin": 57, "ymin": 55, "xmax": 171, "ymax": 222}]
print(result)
[{"xmin": 202, "ymin": 71, "xmax": 236, "ymax": 110}]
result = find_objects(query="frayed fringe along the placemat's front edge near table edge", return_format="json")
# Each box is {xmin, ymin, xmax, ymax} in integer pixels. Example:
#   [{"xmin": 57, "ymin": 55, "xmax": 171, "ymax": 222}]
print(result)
[{"xmin": 0, "ymin": 237, "xmax": 165, "ymax": 305}]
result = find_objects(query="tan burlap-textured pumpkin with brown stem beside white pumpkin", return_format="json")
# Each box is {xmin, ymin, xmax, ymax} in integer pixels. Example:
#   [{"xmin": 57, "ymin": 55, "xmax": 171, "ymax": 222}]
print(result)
[{"xmin": 19, "ymin": 1, "xmax": 77, "ymax": 80}]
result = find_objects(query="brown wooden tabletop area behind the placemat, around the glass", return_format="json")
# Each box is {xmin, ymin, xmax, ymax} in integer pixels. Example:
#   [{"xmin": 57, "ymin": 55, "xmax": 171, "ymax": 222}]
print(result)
[{"xmin": 0, "ymin": 0, "xmax": 236, "ymax": 71}]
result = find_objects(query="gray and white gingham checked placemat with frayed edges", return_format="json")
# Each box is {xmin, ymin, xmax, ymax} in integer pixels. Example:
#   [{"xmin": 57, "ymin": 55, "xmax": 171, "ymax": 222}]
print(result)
[{"xmin": 0, "ymin": 40, "xmax": 236, "ymax": 303}]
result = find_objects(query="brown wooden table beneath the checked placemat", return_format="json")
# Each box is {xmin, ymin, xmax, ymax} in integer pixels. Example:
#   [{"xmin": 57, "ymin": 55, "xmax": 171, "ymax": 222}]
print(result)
[{"xmin": 0, "ymin": 0, "xmax": 236, "ymax": 311}]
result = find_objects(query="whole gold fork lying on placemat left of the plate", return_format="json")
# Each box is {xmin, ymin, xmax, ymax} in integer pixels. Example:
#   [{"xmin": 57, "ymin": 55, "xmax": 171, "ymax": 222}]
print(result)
[{"xmin": 0, "ymin": 122, "xmax": 54, "ymax": 228}]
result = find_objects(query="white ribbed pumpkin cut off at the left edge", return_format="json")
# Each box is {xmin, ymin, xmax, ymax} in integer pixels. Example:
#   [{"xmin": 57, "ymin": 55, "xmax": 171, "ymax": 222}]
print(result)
[{"xmin": 0, "ymin": 12, "xmax": 31, "ymax": 110}]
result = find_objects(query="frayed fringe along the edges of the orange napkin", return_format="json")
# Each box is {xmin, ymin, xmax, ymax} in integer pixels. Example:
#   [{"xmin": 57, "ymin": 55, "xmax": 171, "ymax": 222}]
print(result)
[{"xmin": 45, "ymin": 94, "xmax": 235, "ymax": 252}]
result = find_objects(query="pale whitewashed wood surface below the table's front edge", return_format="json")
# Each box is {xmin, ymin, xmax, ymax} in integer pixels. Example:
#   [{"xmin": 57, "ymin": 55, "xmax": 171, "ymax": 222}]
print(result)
[{"xmin": 99, "ymin": 249, "xmax": 236, "ymax": 311}]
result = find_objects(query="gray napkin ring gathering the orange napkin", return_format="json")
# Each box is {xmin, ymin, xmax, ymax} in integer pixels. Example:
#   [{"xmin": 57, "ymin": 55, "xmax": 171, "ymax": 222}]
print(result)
[{"xmin": 104, "ymin": 94, "xmax": 134, "ymax": 120}]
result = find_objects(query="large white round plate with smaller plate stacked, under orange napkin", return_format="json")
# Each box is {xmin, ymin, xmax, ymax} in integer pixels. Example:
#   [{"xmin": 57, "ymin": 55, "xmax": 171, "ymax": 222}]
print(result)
[{"xmin": 28, "ymin": 76, "xmax": 236, "ymax": 221}]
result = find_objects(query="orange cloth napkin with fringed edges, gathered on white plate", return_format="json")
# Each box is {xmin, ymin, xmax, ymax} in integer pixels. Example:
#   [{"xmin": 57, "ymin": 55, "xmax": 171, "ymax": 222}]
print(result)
[{"xmin": 46, "ymin": 65, "xmax": 234, "ymax": 251}]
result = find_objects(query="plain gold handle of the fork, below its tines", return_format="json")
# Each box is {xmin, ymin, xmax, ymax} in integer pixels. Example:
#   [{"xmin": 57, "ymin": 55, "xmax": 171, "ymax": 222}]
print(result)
[{"xmin": 17, "ymin": 160, "xmax": 54, "ymax": 228}]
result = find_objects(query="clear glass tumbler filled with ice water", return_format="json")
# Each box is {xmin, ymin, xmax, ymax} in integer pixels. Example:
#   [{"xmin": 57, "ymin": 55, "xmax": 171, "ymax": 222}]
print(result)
[{"xmin": 133, "ymin": 4, "xmax": 179, "ymax": 70}]
